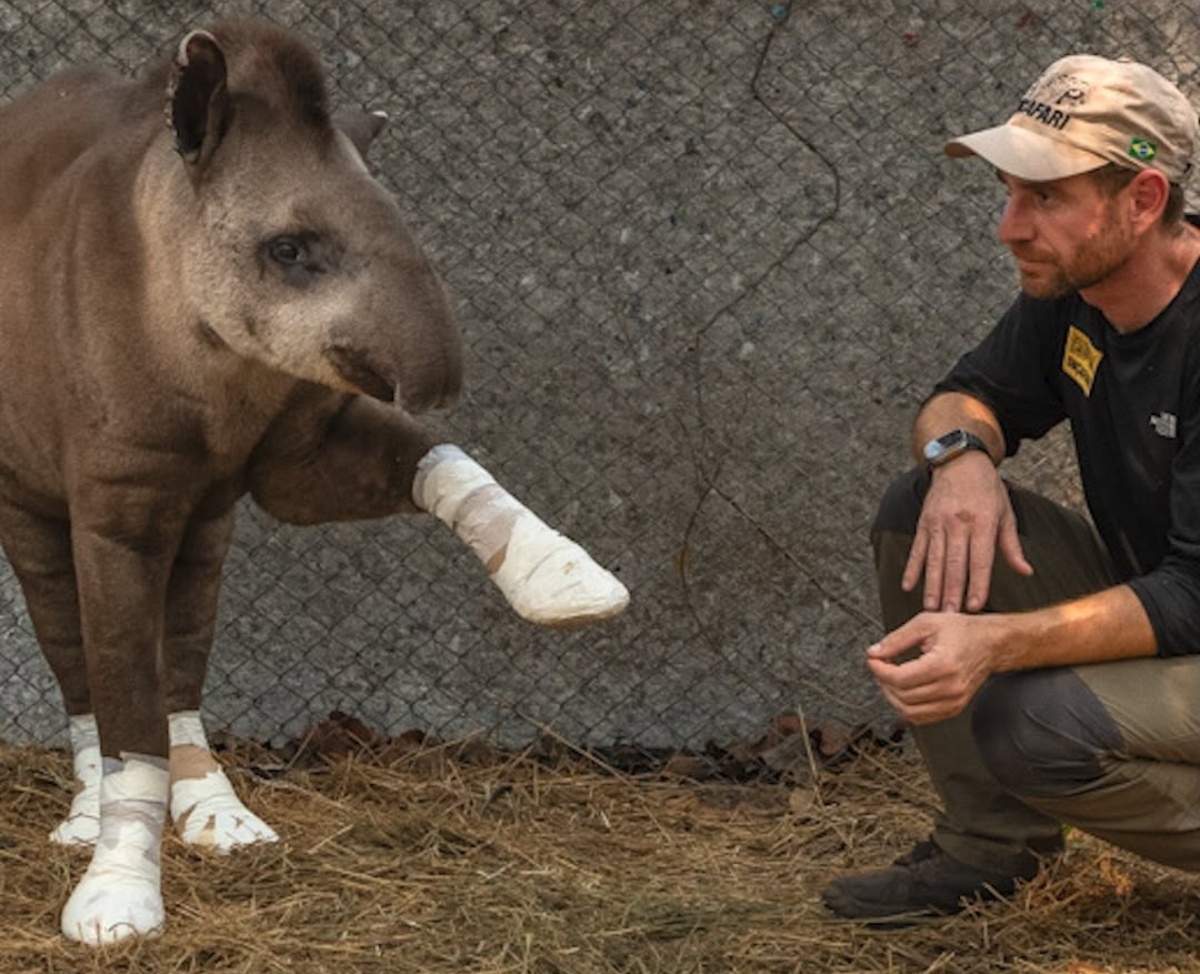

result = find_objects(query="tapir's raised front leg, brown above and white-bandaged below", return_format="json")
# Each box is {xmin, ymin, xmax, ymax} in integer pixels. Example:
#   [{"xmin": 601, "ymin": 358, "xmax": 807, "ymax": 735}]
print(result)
[{"xmin": 250, "ymin": 397, "xmax": 629, "ymax": 626}]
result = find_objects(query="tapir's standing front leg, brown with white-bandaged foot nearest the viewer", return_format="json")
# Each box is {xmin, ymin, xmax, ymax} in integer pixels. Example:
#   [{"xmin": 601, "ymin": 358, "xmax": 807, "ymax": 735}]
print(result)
[{"xmin": 62, "ymin": 510, "xmax": 178, "ymax": 944}]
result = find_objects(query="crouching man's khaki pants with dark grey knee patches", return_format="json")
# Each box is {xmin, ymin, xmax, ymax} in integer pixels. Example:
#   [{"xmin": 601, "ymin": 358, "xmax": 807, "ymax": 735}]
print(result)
[{"xmin": 871, "ymin": 470, "xmax": 1200, "ymax": 874}]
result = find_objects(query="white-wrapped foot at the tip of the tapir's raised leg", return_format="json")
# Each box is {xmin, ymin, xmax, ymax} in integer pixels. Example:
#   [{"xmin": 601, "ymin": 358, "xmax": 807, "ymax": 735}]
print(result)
[{"xmin": 492, "ymin": 516, "xmax": 629, "ymax": 626}]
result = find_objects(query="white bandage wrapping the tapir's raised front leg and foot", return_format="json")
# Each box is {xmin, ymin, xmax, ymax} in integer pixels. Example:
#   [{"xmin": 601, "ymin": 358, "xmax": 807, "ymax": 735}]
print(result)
[{"xmin": 413, "ymin": 444, "xmax": 629, "ymax": 626}]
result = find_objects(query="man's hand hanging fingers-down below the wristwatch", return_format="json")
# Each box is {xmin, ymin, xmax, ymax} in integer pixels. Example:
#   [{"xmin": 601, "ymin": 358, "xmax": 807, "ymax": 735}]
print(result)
[{"xmin": 901, "ymin": 451, "xmax": 1033, "ymax": 612}]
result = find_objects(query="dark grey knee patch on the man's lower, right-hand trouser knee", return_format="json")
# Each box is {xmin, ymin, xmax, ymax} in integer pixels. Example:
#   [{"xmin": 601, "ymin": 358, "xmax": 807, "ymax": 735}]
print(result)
[{"xmin": 971, "ymin": 668, "xmax": 1122, "ymax": 798}]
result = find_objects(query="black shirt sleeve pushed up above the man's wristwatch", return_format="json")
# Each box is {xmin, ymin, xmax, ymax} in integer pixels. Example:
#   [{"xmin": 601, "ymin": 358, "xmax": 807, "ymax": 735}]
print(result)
[{"xmin": 934, "ymin": 294, "xmax": 1068, "ymax": 456}]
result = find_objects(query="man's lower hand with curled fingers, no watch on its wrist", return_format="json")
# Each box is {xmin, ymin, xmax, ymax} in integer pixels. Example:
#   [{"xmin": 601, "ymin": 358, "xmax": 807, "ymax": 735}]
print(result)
[{"xmin": 866, "ymin": 612, "xmax": 1003, "ymax": 723}]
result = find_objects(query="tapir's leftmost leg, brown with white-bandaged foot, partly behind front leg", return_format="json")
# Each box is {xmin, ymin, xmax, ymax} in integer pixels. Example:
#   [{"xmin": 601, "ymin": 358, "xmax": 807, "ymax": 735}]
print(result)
[{"xmin": 0, "ymin": 503, "xmax": 101, "ymax": 846}]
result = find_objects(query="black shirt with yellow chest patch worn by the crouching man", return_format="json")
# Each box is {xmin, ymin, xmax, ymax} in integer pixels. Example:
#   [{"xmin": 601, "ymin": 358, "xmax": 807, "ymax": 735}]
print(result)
[{"xmin": 935, "ymin": 243, "xmax": 1200, "ymax": 656}]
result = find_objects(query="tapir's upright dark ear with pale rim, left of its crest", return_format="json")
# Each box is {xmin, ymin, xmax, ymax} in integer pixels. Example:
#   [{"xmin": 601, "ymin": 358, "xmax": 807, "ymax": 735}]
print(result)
[{"xmin": 167, "ymin": 30, "xmax": 229, "ymax": 166}]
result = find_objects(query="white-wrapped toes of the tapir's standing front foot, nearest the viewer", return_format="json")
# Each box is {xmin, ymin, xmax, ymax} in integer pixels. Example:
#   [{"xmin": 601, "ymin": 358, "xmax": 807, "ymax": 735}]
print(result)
[{"xmin": 62, "ymin": 868, "xmax": 166, "ymax": 946}]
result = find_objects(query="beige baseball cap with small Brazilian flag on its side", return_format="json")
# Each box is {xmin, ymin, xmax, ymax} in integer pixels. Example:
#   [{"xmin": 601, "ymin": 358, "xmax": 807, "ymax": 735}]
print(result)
[{"xmin": 946, "ymin": 54, "xmax": 1200, "ymax": 184}]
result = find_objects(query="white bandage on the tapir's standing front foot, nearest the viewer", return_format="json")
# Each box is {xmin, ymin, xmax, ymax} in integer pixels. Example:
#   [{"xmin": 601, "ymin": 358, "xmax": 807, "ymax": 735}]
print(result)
[{"xmin": 62, "ymin": 754, "xmax": 167, "ymax": 946}]
